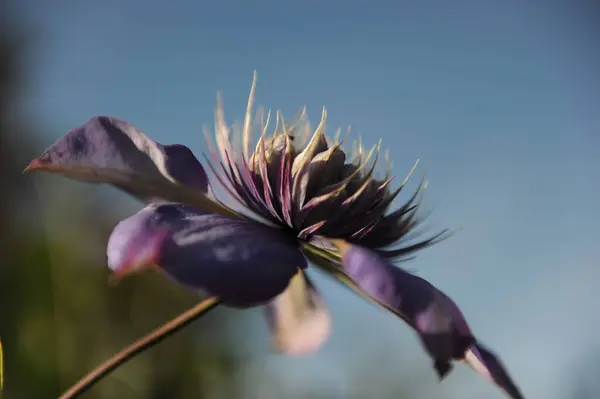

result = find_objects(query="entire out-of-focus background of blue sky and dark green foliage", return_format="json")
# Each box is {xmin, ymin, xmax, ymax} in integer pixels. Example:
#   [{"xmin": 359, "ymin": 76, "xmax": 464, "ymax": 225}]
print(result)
[{"xmin": 0, "ymin": 0, "xmax": 600, "ymax": 399}]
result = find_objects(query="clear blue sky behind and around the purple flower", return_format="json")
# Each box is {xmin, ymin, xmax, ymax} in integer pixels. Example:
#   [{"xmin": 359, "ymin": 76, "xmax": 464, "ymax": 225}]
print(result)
[{"xmin": 10, "ymin": 0, "xmax": 600, "ymax": 399}]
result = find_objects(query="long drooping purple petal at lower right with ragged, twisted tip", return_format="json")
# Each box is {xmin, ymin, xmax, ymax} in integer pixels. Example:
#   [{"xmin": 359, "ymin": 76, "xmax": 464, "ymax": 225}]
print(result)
[{"xmin": 333, "ymin": 240, "xmax": 522, "ymax": 398}]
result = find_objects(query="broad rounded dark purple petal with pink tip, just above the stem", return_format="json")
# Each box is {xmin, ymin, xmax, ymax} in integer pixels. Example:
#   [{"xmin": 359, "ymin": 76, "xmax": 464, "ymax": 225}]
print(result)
[{"xmin": 107, "ymin": 204, "xmax": 306, "ymax": 307}]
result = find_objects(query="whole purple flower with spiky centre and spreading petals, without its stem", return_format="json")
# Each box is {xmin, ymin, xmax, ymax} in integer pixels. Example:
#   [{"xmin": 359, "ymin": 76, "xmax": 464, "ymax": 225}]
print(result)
[{"xmin": 26, "ymin": 74, "xmax": 523, "ymax": 398}]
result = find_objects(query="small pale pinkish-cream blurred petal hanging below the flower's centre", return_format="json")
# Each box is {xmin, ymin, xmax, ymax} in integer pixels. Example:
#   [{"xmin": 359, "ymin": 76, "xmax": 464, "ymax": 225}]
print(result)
[{"xmin": 265, "ymin": 271, "xmax": 331, "ymax": 355}]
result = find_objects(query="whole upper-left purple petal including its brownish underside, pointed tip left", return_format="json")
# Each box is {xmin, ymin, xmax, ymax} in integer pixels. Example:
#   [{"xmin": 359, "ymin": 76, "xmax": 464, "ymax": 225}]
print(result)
[{"xmin": 25, "ymin": 116, "xmax": 235, "ymax": 216}]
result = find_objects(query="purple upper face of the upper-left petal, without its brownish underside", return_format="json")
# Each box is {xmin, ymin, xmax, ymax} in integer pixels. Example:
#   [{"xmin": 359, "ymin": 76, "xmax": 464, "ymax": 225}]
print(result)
[{"xmin": 28, "ymin": 116, "xmax": 208, "ymax": 193}]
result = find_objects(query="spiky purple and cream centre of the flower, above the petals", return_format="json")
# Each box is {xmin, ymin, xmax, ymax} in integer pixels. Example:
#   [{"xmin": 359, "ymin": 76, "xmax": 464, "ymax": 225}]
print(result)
[{"xmin": 204, "ymin": 76, "xmax": 444, "ymax": 257}]
